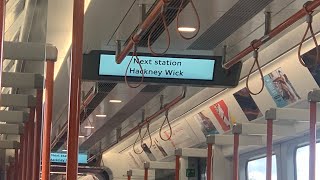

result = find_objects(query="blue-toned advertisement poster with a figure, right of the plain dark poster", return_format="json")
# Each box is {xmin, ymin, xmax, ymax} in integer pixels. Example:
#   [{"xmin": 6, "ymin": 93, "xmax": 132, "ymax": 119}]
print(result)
[{"xmin": 264, "ymin": 68, "xmax": 301, "ymax": 108}]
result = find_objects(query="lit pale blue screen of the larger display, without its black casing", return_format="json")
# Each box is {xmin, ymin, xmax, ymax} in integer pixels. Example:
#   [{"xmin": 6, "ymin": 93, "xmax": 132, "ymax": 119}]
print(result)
[{"xmin": 99, "ymin": 54, "xmax": 215, "ymax": 80}]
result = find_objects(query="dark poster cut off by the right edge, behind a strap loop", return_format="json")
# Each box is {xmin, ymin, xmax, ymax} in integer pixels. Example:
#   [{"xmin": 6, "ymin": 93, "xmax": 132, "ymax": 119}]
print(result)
[{"xmin": 302, "ymin": 45, "xmax": 320, "ymax": 86}]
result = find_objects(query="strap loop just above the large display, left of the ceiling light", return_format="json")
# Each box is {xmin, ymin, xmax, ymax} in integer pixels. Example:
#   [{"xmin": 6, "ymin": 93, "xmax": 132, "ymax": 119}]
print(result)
[{"xmin": 148, "ymin": 5, "xmax": 171, "ymax": 56}]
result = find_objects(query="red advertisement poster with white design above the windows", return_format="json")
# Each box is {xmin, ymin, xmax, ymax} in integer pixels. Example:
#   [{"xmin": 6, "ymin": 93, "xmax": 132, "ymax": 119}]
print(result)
[{"xmin": 210, "ymin": 100, "xmax": 234, "ymax": 132}]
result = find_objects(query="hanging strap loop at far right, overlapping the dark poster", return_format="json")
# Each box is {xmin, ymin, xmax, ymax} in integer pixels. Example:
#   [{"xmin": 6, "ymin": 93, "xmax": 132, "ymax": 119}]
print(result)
[{"xmin": 298, "ymin": 1, "xmax": 319, "ymax": 68}]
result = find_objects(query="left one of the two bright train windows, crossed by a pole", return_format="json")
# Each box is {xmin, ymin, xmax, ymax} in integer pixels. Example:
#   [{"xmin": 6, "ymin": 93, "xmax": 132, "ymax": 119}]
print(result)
[{"xmin": 247, "ymin": 155, "xmax": 277, "ymax": 180}]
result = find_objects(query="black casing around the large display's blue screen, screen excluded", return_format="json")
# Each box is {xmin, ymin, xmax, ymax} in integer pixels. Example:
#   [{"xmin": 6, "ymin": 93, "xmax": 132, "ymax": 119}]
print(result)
[{"xmin": 82, "ymin": 51, "xmax": 242, "ymax": 87}]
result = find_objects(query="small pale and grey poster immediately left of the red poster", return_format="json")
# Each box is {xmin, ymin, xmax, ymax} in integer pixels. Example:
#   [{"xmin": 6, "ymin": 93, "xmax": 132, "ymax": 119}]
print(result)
[{"xmin": 194, "ymin": 110, "xmax": 219, "ymax": 136}]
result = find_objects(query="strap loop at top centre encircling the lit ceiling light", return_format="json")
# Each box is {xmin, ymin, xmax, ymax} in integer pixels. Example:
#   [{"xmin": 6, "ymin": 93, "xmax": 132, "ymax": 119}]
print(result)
[{"xmin": 176, "ymin": 0, "xmax": 201, "ymax": 40}]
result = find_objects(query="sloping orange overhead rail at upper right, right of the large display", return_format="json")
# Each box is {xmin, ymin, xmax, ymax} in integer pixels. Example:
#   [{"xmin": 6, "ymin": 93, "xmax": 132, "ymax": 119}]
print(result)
[{"xmin": 224, "ymin": 0, "xmax": 320, "ymax": 69}]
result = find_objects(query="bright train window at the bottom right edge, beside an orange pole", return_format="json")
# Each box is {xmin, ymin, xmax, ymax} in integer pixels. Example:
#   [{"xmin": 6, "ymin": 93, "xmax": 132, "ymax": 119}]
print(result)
[{"xmin": 295, "ymin": 143, "xmax": 320, "ymax": 180}]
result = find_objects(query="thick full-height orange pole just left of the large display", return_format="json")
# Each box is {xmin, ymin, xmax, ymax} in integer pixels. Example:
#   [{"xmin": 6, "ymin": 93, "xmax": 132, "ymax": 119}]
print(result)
[{"xmin": 67, "ymin": 0, "xmax": 84, "ymax": 180}]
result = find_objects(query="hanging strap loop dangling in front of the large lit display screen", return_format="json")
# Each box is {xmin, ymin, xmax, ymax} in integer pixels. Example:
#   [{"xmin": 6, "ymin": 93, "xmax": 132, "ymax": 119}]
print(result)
[{"xmin": 124, "ymin": 40, "xmax": 144, "ymax": 88}]
